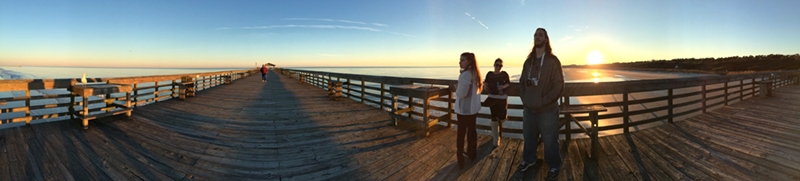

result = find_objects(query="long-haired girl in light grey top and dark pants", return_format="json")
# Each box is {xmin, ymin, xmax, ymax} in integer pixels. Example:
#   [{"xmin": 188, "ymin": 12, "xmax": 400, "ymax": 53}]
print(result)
[{"xmin": 453, "ymin": 52, "xmax": 483, "ymax": 168}]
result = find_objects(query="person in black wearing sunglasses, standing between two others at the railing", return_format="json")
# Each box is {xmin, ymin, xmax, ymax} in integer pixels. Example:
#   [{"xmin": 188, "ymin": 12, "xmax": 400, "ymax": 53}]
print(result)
[{"xmin": 483, "ymin": 58, "xmax": 511, "ymax": 147}]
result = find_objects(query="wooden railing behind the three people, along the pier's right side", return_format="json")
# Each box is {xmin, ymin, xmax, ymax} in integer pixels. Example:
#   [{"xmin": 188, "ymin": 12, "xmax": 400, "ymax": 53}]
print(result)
[{"xmin": 278, "ymin": 69, "xmax": 800, "ymax": 134}]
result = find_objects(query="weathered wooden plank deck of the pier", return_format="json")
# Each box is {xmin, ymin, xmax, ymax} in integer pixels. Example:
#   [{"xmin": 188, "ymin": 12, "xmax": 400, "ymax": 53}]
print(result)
[{"xmin": 0, "ymin": 72, "xmax": 800, "ymax": 180}]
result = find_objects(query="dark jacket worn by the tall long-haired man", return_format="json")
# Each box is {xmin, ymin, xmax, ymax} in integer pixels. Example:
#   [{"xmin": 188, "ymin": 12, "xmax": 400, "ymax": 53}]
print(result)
[{"xmin": 519, "ymin": 52, "xmax": 564, "ymax": 112}]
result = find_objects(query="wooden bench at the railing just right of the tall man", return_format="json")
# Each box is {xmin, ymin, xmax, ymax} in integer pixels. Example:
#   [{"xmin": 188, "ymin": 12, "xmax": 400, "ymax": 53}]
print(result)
[{"xmin": 558, "ymin": 105, "xmax": 608, "ymax": 158}]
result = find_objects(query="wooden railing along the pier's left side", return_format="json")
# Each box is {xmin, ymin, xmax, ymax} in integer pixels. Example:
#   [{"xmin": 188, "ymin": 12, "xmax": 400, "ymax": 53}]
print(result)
[{"xmin": 0, "ymin": 69, "xmax": 258, "ymax": 124}]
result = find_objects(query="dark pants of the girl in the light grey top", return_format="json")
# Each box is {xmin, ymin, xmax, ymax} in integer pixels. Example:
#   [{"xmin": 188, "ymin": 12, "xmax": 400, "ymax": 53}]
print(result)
[{"xmin": 456, "ymin": 114, "xmax": 478, "ymax": 165}]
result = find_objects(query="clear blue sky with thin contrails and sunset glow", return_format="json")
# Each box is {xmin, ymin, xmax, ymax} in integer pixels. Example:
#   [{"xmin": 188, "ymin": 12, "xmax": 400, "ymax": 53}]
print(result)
[{"xmin": 0, "ymin": 0, "xmax": 800, "ymax": 68}]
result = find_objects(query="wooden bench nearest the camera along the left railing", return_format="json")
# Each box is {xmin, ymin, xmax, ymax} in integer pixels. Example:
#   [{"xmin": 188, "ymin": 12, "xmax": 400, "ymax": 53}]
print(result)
[{"xmin": 70, "ymin": 84, "xmax": 133, "ymax": 129}]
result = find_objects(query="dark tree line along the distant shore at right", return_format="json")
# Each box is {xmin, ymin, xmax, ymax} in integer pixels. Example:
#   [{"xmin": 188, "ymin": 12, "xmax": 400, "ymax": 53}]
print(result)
[{"xmin": 588, "ymin": 54, "xmax": 800, "ymax": 74}]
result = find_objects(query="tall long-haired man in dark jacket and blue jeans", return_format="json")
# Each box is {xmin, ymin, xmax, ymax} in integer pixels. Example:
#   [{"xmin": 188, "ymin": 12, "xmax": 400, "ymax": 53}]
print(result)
[{"xmin": 518, "ymin": 28, "xmax": 564, "ymax": 180}]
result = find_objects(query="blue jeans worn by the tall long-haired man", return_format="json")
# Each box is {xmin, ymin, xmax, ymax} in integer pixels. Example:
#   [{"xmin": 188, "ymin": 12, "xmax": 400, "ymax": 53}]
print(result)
[{"xmin": 522, "ymin": 109, "xmax": 561, "ymax": 168}]
